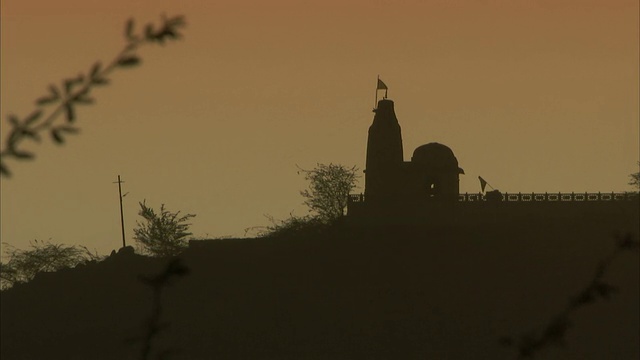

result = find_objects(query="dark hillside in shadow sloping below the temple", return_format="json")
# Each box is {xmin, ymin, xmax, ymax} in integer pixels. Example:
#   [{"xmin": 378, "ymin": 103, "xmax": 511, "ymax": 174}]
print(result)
[{"xmin": 0, "ymin": 204, "xmax": 640, "ymax": 360}]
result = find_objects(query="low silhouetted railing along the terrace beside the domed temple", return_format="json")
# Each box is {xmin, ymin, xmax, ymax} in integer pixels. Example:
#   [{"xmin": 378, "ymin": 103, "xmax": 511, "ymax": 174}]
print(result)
[{"xmin": 349, "ymin": 192, "xmax": 639, "ymax": 203}]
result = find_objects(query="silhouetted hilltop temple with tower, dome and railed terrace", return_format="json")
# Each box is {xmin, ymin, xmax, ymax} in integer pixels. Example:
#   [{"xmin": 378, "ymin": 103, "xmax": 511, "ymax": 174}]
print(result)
[{"xmin": 348, "ymin": 98, "xmax": 638, "ymax": 224}]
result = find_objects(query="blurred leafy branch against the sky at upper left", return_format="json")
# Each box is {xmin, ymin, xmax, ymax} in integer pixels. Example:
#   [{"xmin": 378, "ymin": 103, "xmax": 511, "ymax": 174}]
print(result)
[{"xmin": 0, "ymin": 16, "xmax": 185, "ymax": 177}]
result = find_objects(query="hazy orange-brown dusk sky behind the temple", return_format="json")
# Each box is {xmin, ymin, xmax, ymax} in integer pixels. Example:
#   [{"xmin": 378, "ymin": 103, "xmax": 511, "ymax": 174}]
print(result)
[{"xmin": 0, "ymin": 0, "xmax": 639, "ymax": 254}]
